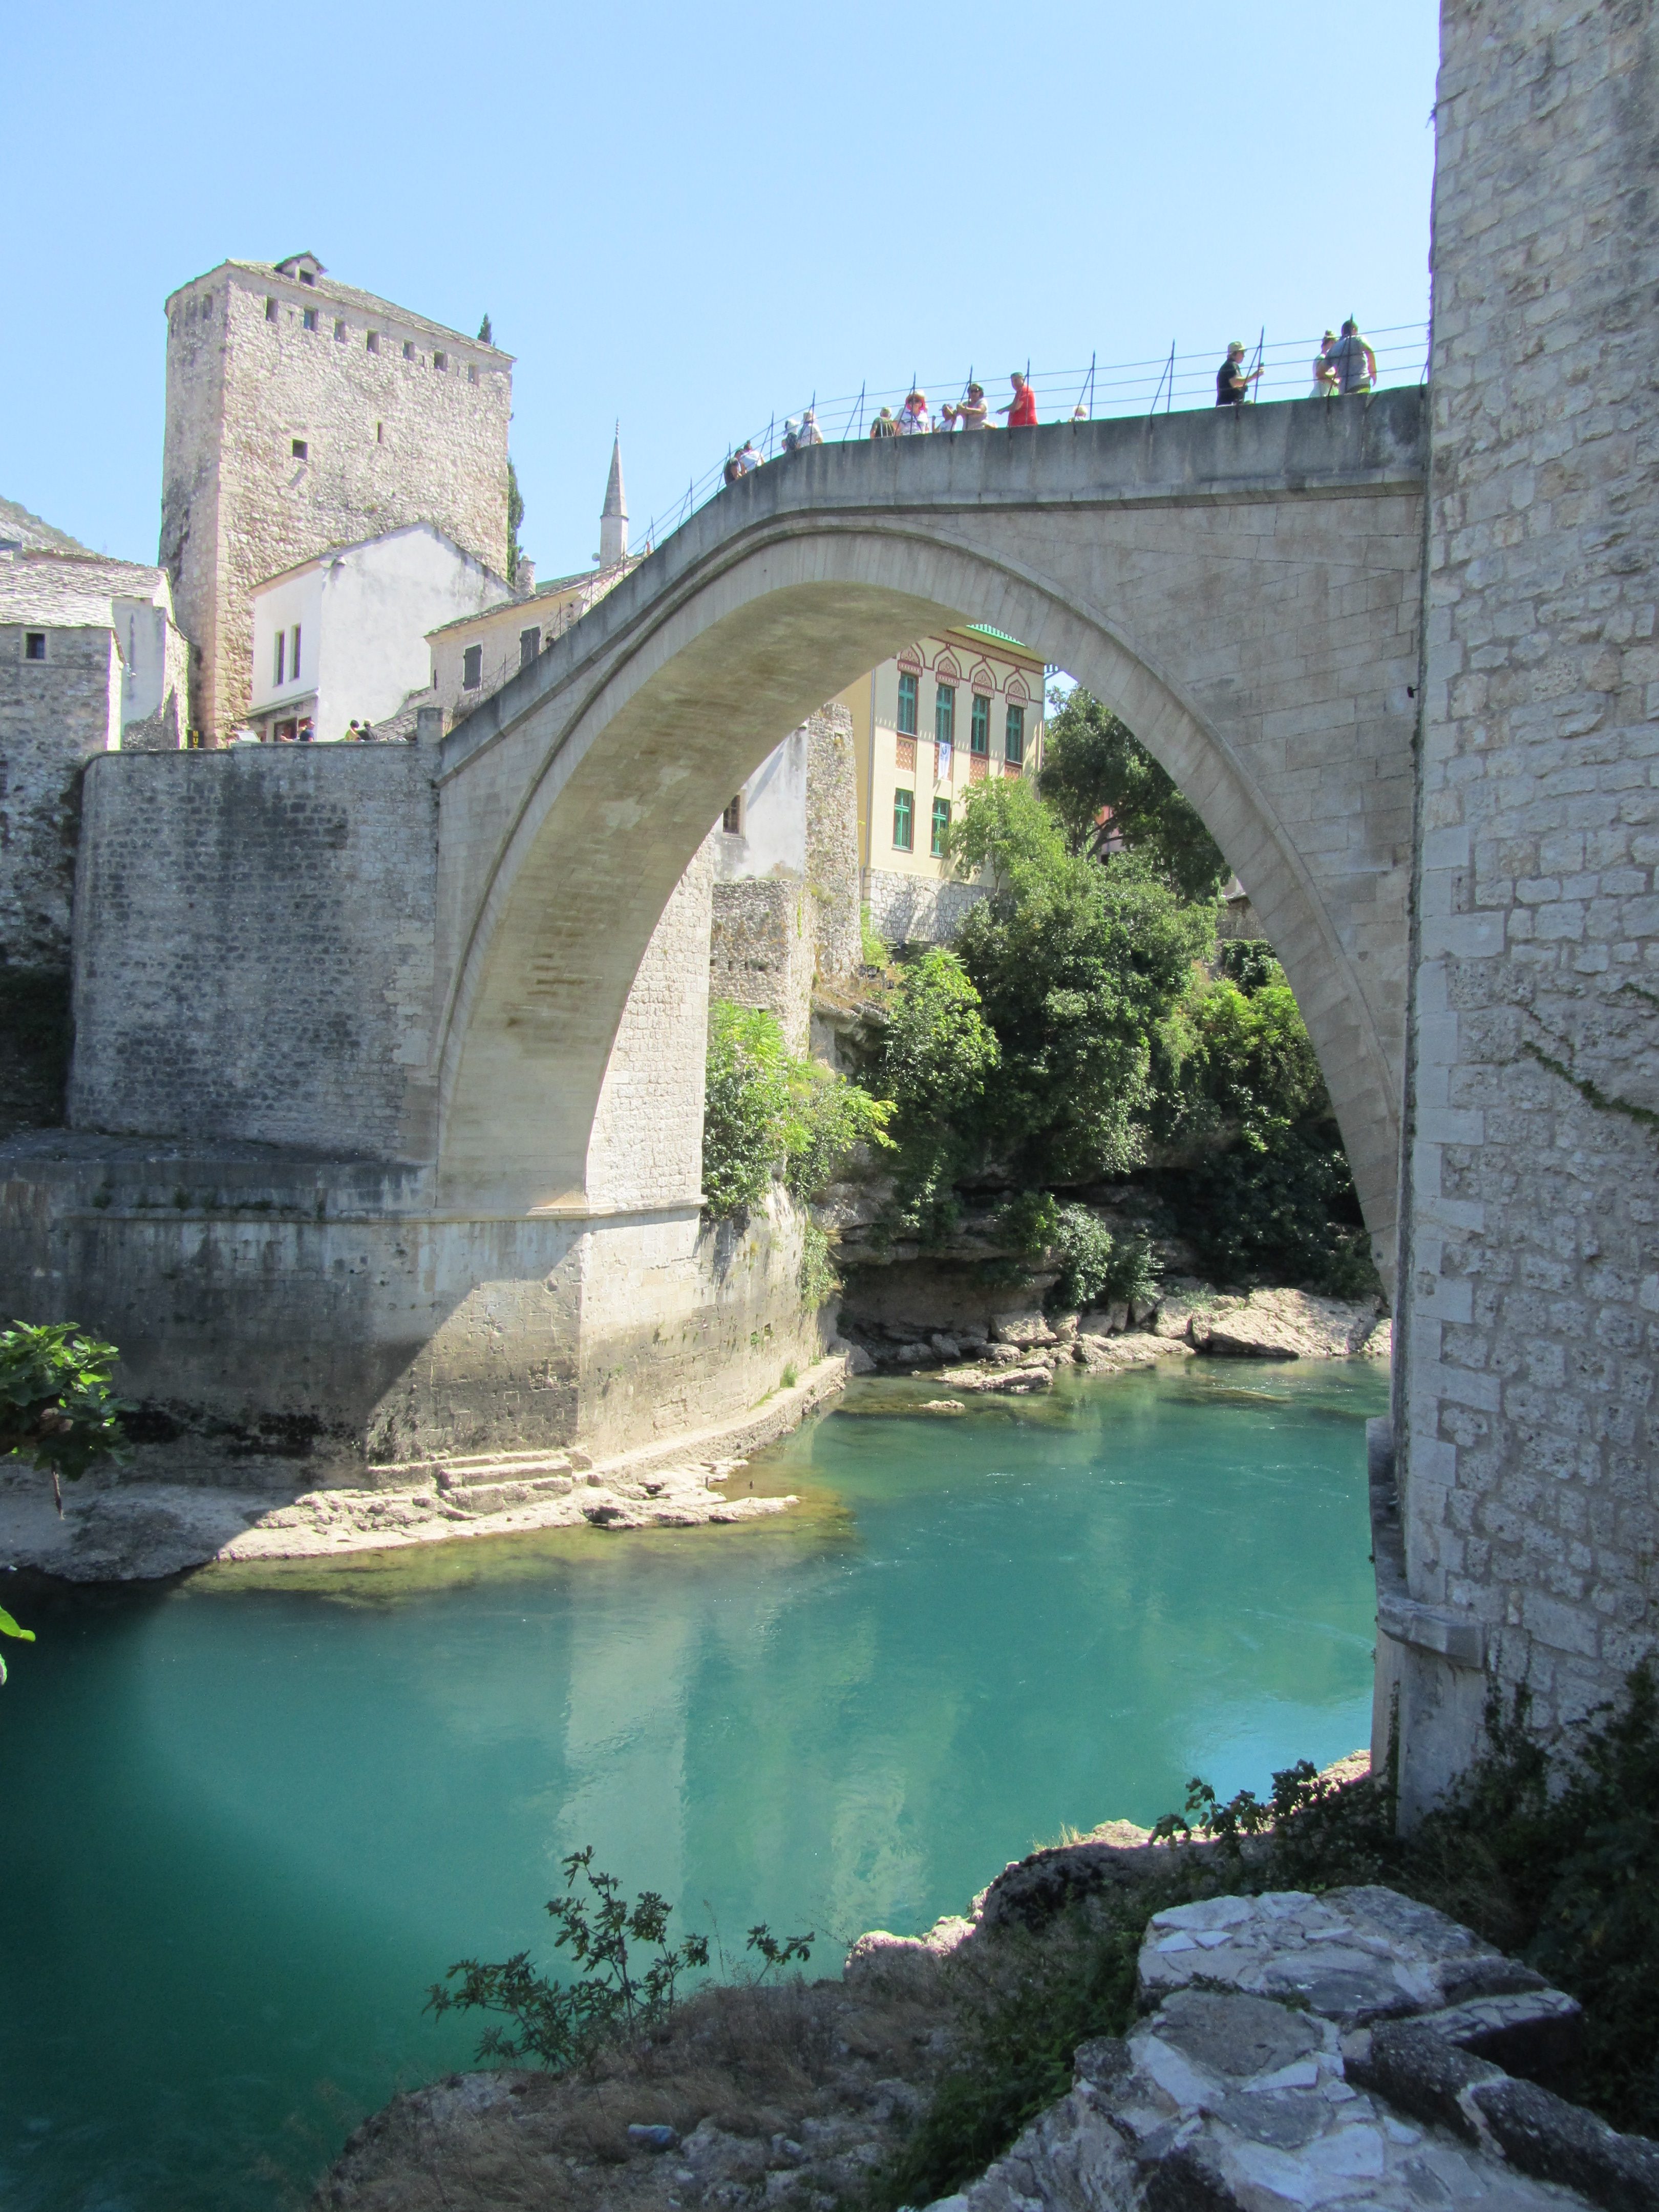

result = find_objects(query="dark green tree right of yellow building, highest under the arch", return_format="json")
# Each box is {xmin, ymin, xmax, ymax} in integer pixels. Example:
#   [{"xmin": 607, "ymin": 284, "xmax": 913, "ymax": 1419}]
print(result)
[{"xmin": 1037, "ymin": 688, "xmax": 1228, "ymax": 900}]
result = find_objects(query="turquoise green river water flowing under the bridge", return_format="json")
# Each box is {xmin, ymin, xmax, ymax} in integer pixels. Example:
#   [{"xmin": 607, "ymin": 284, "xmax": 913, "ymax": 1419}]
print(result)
[{"xmin": 0, "ymin": 1360, "xmax": 1385, "ymax": 2212}]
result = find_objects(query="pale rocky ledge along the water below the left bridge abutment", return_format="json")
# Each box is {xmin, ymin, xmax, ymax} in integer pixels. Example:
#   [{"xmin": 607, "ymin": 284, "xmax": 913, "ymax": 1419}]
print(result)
[{"xmin": 0, "ymin": 1354, "xmax": 847, "ymax": 1582}]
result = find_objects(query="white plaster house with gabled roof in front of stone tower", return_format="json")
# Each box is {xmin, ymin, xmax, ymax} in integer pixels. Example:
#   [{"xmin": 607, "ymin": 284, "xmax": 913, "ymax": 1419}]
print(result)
[{"xmin": 250, "ymin": 522, "xmax": 513, "ymax": 743}]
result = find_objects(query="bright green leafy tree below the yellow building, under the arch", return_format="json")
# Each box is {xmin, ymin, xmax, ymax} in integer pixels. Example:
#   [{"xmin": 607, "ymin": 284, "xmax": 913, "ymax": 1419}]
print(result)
[{"xmin": 951, "ymin": 781, "xmax": 1215, "ymax": 1186}]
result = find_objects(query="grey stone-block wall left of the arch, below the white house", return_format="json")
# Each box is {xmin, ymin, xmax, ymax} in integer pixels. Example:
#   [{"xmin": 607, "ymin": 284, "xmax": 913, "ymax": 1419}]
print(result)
[{"xmin": 69, "ymin": 746, "xmax": 438, "ymax": 1159}]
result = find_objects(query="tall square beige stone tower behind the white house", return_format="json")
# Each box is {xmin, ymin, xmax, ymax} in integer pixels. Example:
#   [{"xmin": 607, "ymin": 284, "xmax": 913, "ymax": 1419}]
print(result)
[{"xmin": 161, "ymin": 254, "xmax": 517, "ymax": 746}]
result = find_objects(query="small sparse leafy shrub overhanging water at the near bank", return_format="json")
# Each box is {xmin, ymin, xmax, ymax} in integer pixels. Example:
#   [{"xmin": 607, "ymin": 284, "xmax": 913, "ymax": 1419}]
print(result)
[{"xmin": 424, "ymin": 1845, "xmax": 816, "ymax": 2073}]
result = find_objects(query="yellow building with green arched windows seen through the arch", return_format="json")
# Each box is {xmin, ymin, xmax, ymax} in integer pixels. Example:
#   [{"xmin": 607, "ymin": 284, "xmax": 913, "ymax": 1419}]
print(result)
[{"xmin": 836, "ymin": 624, "xmax": 1044, "ymax": 942}]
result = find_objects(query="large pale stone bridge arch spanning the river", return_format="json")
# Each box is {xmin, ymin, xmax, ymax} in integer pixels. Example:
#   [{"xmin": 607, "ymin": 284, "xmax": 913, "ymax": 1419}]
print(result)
[{"xmin": 438, "ymin": 394, "xmax": 1420, "ymax": 1261}]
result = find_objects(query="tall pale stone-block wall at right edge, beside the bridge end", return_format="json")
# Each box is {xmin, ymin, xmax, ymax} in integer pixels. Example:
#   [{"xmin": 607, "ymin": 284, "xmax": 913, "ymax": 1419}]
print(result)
[{"xmin": 1389, "ymin": 0, "xmax": 1659, "ymax": 1800}]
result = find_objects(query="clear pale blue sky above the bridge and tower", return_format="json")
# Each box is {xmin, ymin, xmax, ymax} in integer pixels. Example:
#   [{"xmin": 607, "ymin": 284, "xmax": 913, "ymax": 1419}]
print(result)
[{"xmin": 0, "ymin": 0, "xmax": 1436, "ymax": 575}]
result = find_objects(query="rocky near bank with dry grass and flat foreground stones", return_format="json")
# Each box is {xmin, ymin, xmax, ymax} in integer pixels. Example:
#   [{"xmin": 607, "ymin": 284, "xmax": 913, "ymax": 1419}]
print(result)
[{"xmin": 314, "ymin": 1756, "xmax": 1659, "ymax": 2212}]
